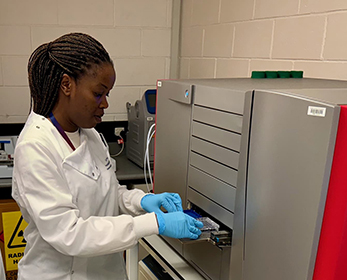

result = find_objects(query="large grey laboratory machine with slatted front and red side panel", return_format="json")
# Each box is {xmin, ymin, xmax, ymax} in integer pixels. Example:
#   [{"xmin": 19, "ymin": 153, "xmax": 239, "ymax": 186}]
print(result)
[{"xmin": 154, "ymin": 78, "xmax": 347, "ymax": 280}]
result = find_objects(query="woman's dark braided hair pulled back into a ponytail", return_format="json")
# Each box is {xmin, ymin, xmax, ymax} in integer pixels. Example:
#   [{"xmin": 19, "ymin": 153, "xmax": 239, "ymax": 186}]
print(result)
[{"xmin": 28, "ymin": 33, "xmax": 113, "ymax": 117}]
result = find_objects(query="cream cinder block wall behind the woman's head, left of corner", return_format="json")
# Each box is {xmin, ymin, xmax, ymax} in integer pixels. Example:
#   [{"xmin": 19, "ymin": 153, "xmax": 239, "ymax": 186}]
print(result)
[{"xmin": 0, "ymin": 0, "xmax": 172, "ymax": 123}]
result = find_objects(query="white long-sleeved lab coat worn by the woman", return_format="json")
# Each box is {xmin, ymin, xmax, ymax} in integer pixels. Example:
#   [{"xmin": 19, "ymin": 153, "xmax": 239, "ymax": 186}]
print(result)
[{"xmin": 12, "ymin": 113, "xmax": 158, "ymax": 280}]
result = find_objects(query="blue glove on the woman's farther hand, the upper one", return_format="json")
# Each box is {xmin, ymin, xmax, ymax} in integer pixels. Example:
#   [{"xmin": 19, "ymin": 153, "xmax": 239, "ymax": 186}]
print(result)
[{"xmin": 141, "ymin": 192, "xmax": 183, "ymax": 213}]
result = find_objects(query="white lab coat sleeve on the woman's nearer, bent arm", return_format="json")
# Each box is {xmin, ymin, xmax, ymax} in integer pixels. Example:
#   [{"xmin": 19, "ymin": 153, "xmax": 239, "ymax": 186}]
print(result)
[{"xmin": 14, "ymin": 141, "xmax": 158, "ymax": 257}]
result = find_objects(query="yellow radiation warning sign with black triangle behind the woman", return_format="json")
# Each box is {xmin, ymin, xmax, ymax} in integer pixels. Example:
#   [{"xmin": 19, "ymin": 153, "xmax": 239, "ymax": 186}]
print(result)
[{"xmin": 2, "ymin": 211, "xmax": 28, "ymax": 271}]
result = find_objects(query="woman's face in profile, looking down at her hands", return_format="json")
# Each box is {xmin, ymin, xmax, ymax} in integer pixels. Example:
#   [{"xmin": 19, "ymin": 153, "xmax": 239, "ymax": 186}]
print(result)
[{"xmin": 68, "ymin": 63, "xmax": 116, "ymax": 129}]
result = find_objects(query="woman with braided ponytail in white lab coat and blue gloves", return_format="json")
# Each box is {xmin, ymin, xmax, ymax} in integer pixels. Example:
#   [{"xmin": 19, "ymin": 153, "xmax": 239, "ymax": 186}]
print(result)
[{"xmin": 12, "ymin": 33, "xmax": 202, "ymax": 280}]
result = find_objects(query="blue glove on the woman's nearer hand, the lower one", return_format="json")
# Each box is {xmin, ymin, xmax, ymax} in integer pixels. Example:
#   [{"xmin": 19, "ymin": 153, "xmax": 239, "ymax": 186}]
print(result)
[{"xmin": 156, "ymin": 212, "xmax": 203, "ymax": 239}]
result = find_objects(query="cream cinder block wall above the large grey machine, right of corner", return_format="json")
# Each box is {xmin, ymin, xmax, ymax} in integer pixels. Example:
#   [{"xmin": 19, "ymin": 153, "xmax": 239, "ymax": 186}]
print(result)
[{"xmin": 180, "ymin": 0, "xmax": 347, "ymax": 80}]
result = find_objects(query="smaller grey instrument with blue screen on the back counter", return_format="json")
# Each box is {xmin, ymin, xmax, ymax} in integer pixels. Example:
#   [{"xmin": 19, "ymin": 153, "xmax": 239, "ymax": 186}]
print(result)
[{"xmin": 125, "ymin": 89, "xmax": 157, "ymax": 168}]
